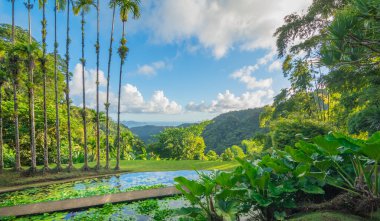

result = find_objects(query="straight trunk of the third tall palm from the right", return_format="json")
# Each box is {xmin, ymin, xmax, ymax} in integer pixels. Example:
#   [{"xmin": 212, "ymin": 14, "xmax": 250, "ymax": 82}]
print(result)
[{"xmin": 95, "ymin": 0, "xmax": 100, "ymax": 170}]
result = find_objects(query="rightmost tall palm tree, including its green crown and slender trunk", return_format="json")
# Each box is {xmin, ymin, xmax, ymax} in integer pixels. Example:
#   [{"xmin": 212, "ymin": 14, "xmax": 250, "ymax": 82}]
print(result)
[{"xmin": 115, "ymin": 0, "xmax": 140, "ymax": 170}]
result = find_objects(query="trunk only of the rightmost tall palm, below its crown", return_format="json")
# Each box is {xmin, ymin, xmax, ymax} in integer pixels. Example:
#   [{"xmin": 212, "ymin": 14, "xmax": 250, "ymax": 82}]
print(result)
[{"xmin": 115, "ymin": 21, "xmax": 126, "ymax": 170}]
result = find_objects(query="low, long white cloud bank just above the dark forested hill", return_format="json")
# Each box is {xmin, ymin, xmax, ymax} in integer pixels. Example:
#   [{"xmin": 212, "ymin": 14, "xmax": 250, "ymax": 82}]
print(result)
[{"xmin": 186, "ymin": 89, "xmax": 274, "ymax": 113}]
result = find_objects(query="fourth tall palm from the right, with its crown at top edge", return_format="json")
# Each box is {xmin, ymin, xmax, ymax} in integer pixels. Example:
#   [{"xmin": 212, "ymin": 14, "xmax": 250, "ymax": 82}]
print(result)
[{"xmin": 74, "ymin": 0, "xmax": 96, "ymax": 171}]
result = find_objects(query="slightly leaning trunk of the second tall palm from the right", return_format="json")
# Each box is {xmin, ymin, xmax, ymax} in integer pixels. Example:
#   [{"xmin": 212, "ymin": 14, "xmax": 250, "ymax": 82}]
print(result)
[{"xmin": 105, "ymin": 4, "xmax": 116, "ymax": 169}]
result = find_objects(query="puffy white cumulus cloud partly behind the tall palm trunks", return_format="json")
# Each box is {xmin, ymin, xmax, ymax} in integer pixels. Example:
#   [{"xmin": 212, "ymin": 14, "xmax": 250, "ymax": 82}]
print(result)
[{"xmin": 70, "ymin": 64, "xmax": 182, "ymax": 114}]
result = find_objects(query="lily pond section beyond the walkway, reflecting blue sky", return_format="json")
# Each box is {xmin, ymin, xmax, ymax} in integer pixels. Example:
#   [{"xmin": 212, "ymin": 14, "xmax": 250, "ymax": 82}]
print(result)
[{"xmin": 0, "ymin": 170, "xmax": 209, "ymax": 207}]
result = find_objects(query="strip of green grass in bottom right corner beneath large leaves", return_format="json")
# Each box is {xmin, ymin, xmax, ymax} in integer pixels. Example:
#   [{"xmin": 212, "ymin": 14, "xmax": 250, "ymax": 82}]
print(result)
[{"xmin": 289, "ymin": 212, "xmax": 380, "ymax": 221}]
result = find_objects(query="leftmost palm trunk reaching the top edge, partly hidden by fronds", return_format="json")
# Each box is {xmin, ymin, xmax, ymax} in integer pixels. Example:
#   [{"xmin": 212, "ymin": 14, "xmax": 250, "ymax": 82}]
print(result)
[{"xmin": 12, "ymin": 0, "xmax": 21, "ymax": 171}]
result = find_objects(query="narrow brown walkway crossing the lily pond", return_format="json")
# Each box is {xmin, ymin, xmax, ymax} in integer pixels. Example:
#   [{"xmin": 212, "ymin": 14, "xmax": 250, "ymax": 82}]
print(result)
[{"xmin": 0, "ymin": 187, "xmax": 180, "ymax": 217}]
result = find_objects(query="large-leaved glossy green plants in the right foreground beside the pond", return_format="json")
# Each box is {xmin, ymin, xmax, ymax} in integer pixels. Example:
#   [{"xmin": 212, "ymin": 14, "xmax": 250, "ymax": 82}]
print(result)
[{"xmin": 175, "ymin": 132, "xmax": 380, "ymax": 220}]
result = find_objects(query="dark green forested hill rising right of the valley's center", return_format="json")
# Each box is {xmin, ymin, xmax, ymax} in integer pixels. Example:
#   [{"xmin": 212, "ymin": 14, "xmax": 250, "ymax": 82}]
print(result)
[{"xmin": 203, "ymin": 108, "xmax": 264, "ymax": 154}]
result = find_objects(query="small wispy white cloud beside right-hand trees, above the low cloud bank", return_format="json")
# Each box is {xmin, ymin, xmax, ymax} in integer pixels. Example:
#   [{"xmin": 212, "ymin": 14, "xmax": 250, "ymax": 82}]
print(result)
[{"xmin": 231, "ymin": 64, "xmax": 273, "ymax": 89}]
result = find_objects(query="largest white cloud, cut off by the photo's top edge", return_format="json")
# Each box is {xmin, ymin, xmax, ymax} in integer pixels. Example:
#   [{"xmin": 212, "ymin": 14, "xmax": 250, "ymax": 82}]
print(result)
[{"xmin": 140, "ymin": 0, "xmax": 312, "ymax": 58}]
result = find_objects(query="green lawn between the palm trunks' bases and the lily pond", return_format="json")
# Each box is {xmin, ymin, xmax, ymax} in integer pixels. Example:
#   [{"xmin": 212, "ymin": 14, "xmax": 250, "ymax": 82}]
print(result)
[{"xmin": 0, "ymin": 160, "xmax": 238, "ymax": 190}]
